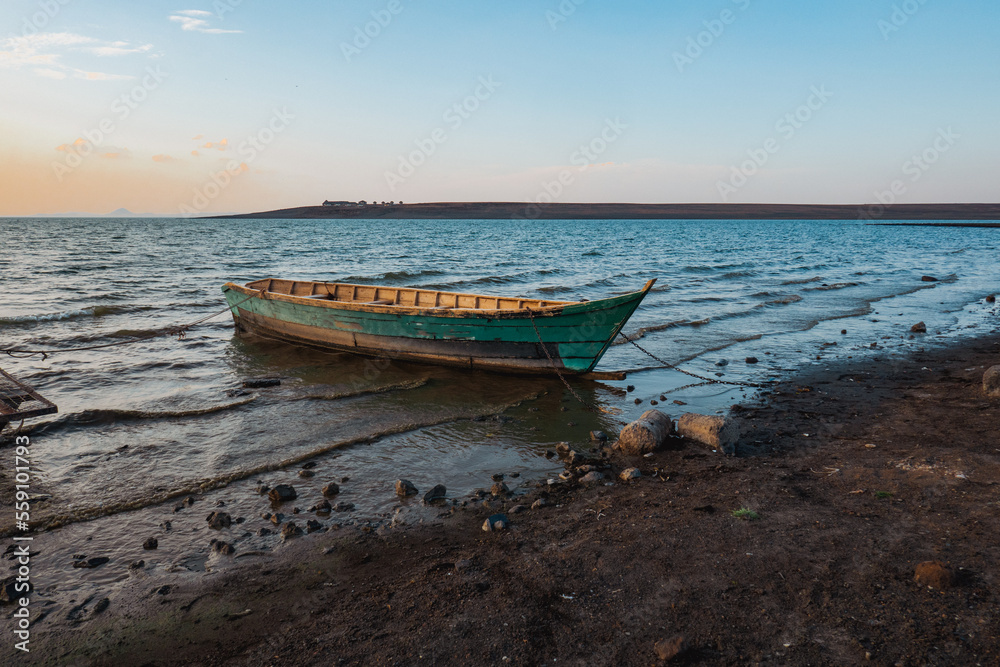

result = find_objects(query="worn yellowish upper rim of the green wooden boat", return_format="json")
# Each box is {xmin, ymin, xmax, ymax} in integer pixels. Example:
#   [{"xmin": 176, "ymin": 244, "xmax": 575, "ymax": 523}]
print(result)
[{"xmin": 222, "ymin": 278, "xmax": 656, "ymax": 319}]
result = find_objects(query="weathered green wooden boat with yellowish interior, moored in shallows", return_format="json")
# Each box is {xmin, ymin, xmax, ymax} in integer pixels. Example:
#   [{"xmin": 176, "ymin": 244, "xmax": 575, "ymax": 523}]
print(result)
[{"xmin": 222, "ymin": 278, "xmax": 656, "ymax": 374}]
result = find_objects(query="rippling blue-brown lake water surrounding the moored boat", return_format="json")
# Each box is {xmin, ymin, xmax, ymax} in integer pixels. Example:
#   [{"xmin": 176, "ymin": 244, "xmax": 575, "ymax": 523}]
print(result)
[{"xmin": 0, "ymin": 219, "xmax": 1000, "ymax": 636}]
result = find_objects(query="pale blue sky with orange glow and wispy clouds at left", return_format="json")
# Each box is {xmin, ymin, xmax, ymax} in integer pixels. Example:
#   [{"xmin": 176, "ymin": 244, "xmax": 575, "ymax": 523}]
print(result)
[{"xmin": 0, "ymin": 0, "xmax": 1000, "ymax": 216}]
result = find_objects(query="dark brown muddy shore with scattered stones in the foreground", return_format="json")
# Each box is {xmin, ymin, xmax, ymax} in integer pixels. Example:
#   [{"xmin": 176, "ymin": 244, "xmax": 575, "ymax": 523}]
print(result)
[{"xmin": 13, "ymin": 335, "xmax": 1000, "ymax": 665}]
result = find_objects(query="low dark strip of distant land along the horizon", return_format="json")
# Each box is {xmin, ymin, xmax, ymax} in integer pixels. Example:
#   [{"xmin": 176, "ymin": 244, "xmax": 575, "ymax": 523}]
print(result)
[{"xmin": 206, "ymin": 202, "xmax": 1000, "ymax": 227}]
